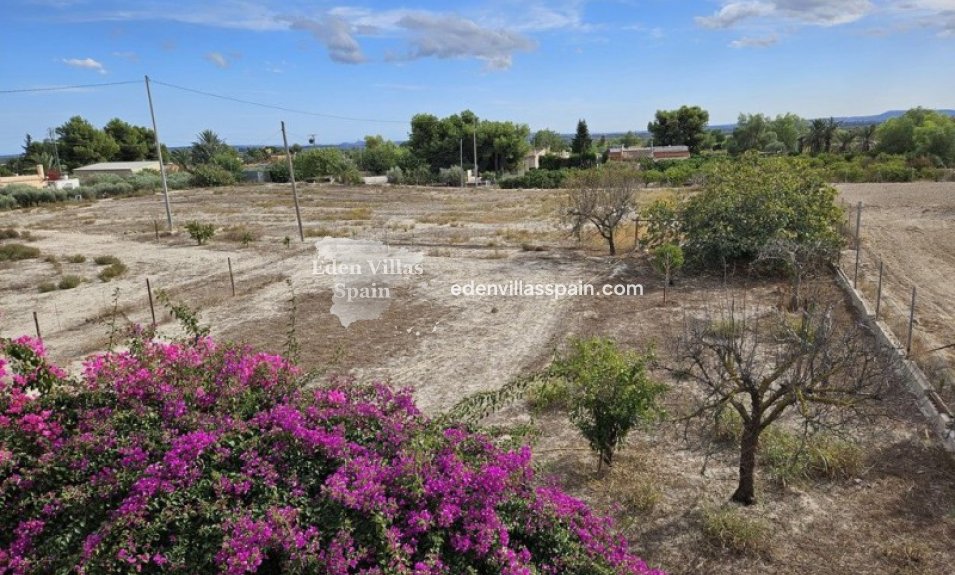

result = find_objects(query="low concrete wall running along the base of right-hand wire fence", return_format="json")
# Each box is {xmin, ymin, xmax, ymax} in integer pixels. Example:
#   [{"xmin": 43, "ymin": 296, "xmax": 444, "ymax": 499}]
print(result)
[{"xmin": 836, "ymin": 268, "xmax": 955, "ymax": 453}]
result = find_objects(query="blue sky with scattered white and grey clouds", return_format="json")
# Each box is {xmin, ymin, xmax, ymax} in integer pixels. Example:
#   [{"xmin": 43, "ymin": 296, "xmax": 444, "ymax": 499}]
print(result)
[{"xmin": 0, "ymin": 0, "xmax": 955, "ymax": 153}]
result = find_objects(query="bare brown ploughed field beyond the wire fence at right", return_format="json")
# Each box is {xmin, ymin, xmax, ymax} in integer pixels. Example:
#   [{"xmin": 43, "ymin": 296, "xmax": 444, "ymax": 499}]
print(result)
[{"xmin": 838, "ymin": 182, "xmax": 955, "ymax": 410}]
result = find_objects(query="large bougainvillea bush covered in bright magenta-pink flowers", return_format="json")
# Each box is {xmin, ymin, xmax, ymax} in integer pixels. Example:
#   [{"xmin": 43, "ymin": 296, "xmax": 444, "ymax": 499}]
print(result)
[{"xmin": 0, "ymin": 334, "xmax": 661, "ymax": 575}]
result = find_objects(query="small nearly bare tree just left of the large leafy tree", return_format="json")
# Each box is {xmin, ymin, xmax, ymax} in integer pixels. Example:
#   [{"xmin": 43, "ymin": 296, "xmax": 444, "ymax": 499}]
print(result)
[{"xmin": 563, "ymin": 164, "xmax": 640, "ymax": 255}]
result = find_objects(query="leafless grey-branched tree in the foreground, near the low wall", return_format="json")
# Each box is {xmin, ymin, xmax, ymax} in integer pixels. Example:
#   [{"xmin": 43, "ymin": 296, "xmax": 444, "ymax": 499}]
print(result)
[{"xmin": 671, "ymin": 303, "xmax": 887, "ymax": 505}]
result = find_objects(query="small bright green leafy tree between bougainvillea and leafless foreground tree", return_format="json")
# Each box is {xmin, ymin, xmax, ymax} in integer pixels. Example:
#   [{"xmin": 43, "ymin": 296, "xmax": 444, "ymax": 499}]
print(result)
[{"xmin": 549, "ymin": 338, "xmax": 666, "ymax": 473}]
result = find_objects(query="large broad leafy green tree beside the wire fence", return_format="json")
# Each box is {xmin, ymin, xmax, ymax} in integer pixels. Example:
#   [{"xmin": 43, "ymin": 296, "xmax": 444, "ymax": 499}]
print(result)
[{"xmin": 682, "ymin": 153, "xmax": 843, "ymax": 270}]
